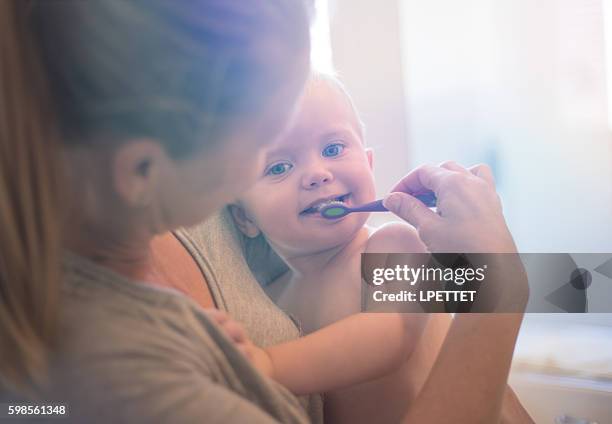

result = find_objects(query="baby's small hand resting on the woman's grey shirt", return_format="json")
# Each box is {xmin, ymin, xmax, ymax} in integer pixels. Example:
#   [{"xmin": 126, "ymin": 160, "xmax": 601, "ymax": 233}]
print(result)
[{"xmin": 206, "ymin": 308, "xmax": 273, "ymax": 377}]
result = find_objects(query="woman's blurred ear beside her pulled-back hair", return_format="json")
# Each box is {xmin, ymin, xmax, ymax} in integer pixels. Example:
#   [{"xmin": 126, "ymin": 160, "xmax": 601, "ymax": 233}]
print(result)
[{"xmin": 112, "ymin": 139, "xmax": 170, "ymax": 207}]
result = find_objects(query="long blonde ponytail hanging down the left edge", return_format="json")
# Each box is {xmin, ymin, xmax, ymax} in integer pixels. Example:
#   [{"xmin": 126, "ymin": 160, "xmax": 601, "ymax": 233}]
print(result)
[{"xmin": 0, "ymin": 1, "xmax": 60, "ymax": 398}]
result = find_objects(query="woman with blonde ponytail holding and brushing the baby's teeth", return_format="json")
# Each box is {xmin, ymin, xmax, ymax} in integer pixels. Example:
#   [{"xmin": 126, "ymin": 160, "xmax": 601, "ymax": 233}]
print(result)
[{"xmin": 0, "ymin": 0, "xmax": 521, "ymax": 422}]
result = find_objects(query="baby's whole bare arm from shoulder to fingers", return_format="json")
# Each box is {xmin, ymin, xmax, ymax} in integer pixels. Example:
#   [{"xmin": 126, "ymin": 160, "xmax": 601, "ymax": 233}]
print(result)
[{"xmin": 210, "ymin": 224, "xmax": 428, "ymax": 395}]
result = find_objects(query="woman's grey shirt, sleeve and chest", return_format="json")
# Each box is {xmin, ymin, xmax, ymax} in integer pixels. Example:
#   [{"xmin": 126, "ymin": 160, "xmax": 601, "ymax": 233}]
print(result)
[{"xmin": 53, "ymin": 211, "xmax": 322, "ymax": 423}]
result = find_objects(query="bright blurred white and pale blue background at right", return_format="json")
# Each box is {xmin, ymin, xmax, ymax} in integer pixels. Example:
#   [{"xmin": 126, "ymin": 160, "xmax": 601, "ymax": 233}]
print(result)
[{"xmin": 312, "ymin": 0, "xmax": 612, "ymax": 423}]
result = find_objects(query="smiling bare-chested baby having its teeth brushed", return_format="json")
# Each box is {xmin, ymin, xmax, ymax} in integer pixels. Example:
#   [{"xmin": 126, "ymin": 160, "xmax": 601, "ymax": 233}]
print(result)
[{"xmin": 230, "ymin": 75, "xmax": 444, "ymax": 422}]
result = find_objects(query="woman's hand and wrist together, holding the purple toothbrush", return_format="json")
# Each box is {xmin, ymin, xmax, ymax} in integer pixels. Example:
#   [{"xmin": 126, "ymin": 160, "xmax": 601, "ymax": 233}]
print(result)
[{"xmin": 384, "ymin": 162, "xmax": 529, "ymax": 312}]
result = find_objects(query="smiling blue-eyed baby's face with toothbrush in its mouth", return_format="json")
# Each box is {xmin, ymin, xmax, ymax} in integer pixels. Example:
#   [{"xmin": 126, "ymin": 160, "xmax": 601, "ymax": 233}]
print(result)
[{"xmin": 235, "ymin": 82, "xmax": 375, "ymax": 255}]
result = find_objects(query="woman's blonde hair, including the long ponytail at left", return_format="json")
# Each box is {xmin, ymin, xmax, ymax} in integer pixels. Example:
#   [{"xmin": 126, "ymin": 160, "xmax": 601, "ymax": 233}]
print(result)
[{"xmin": 0, "ymin": 0, "xmax": 309, "ymax": 393}]
